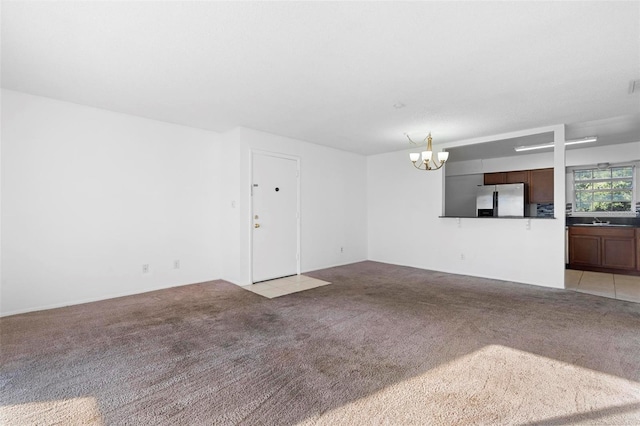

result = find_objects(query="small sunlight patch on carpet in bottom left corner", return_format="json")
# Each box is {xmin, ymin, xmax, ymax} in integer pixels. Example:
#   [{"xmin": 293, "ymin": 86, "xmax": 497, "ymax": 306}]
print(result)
[{"xmin": 0, "ymin": 397, "xmax": 103, "ymax": 426}]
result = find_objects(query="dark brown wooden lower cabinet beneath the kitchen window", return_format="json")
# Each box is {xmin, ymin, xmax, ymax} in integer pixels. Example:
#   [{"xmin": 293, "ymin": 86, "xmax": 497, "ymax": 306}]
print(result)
[{"xmin": 569, "ymin": 226, "xmax": 640, "ymax": 271}]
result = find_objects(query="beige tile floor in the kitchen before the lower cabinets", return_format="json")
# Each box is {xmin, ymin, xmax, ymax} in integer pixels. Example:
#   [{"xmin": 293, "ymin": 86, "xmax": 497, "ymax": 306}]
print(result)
[{"xmin": 564, "ymin": 269, "xmax": 640, "ymax": 303}]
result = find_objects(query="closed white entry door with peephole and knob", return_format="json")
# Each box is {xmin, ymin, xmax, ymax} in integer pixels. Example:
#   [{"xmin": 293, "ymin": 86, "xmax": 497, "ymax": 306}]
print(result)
[{"xmin": 252, "ymin": 153, "xmax": 299, "ymax": 283}]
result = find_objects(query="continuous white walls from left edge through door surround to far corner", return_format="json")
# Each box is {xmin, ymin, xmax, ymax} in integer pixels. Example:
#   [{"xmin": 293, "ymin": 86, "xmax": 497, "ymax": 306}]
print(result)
[{"xmin": 0, "ymin": 90, "xmax": 367, "ymax": 315}]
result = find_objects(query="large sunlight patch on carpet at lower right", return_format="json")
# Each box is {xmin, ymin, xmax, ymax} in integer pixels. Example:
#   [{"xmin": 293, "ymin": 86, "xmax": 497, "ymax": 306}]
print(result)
[{"xmin": 301, "ymin": 345, "xmax": 640, "ymax": 424}]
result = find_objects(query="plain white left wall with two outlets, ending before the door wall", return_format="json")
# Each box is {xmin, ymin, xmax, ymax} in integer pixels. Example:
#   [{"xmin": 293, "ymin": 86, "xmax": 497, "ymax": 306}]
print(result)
[{"xmin": 0, "ymin": 90, "xmax": 223, "ymax": 315}]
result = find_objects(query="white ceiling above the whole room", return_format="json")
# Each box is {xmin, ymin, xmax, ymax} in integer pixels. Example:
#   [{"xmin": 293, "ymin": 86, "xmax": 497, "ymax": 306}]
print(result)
[{"xmin": 1, "ymin": 1, "xmax": 640, "ymax": 155}]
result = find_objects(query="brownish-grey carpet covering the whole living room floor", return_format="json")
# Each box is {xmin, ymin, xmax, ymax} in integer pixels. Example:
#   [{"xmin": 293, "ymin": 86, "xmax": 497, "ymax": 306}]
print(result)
[{"xmin": 0, "ymin": 262, "xmax": 640, "ymax": 425}]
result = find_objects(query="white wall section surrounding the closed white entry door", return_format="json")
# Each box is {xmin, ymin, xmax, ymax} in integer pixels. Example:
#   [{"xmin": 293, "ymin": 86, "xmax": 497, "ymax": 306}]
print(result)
[{"xmin": 222, "ymin": 128, "xmax": 367, "ymax": 285}]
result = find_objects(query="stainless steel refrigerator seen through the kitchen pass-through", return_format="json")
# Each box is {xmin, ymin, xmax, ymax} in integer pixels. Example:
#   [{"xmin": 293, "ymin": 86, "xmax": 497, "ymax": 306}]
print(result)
[{"xmin": 476, "ymin": 183, "xmax": 526, "ymax": 217}]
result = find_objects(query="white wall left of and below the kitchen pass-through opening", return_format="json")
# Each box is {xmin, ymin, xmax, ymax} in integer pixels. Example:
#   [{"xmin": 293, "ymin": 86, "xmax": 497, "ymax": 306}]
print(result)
[{"xmin": 367, "ymin": 146, "xmax": 564, "ymax": 288}]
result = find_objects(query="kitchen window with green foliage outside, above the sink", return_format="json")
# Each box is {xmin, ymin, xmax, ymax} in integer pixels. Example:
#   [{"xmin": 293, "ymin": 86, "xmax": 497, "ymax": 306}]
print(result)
[{"xmin": 573, "ymin": 166, "xmax": 635, "ymax": 213}]
